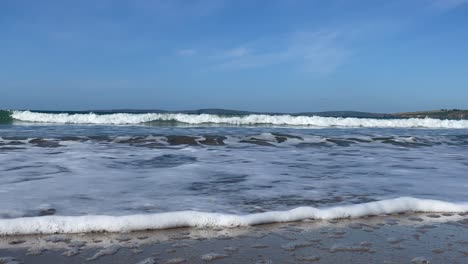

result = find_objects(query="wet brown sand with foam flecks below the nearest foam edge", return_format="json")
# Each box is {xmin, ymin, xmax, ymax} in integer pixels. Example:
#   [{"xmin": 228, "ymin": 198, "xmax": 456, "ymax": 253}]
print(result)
[{"xmin": 0, "ymin": 214, "xmax": 468, "ymax": 264}]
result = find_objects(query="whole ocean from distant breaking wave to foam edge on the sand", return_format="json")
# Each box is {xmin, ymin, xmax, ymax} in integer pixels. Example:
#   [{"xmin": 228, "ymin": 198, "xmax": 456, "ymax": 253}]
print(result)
[{"xmin": 0, "ymin": 111, "xmax": 468, "ymax": 235}]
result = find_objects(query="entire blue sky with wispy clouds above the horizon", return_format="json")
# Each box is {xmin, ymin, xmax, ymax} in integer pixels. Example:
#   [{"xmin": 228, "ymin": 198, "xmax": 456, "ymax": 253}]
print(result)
[{"xmin": 0, "ymin": 0, "xmax": 468, "ymax": 112}]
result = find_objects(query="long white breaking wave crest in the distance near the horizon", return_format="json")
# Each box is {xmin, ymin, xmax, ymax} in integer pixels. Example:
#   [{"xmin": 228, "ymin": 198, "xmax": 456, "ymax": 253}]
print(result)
[{"xmin": 12, "ymin": 111, "xmax": 468, "ymax": 128}]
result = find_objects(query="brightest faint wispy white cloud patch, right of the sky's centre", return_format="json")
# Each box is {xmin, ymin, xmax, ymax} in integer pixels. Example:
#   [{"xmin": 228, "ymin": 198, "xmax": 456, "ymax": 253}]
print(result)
[{"xmin": 219, "ymin": 31, "xmax": 351, "ymax": 74}]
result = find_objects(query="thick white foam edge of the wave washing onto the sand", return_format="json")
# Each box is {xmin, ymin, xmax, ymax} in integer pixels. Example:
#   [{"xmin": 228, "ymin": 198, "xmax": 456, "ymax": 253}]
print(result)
[{"xmin": 0, "ymin": 197, "xmax": 468, "ymax": 235}]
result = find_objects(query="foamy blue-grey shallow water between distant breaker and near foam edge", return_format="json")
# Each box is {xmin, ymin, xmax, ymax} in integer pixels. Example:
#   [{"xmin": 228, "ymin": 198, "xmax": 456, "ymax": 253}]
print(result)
[{"xmin": 0, "ymin": 123, "xmax": 468, "ymax": 221}]
